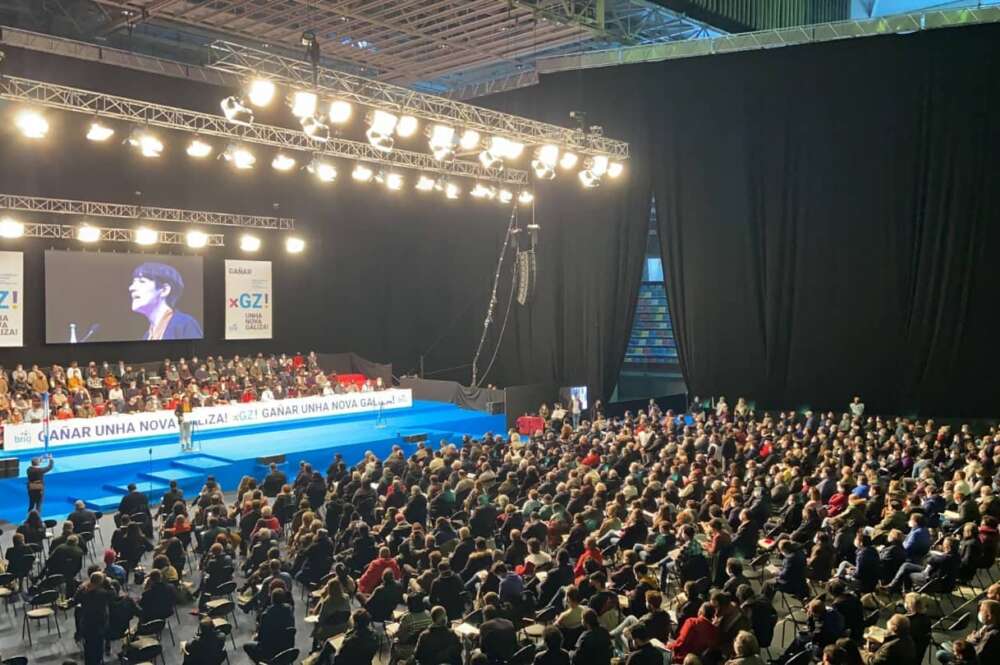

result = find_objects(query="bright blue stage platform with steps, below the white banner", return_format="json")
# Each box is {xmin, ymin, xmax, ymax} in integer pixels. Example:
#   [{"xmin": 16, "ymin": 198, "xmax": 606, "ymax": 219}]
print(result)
[{"xmin": 0, "ymin": 401, "xmax": 506, "ymax": 524}]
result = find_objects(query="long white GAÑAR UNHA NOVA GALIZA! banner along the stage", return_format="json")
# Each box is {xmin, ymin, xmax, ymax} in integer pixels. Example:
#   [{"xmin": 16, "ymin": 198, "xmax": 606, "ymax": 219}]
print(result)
[{"xmin": 3, "ymin": 388, "xmax": 413, "ymax": 451}]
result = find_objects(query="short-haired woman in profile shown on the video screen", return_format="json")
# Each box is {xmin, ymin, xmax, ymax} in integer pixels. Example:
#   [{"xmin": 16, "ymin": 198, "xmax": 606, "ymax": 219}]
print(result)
[{"xmin": 128, "ymin": 262, "xmax": 202, "ymax": 340}]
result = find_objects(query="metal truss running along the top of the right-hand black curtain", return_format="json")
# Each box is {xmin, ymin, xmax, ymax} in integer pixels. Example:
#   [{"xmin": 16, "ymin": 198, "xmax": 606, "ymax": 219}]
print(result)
[{"xmin": 537, "ymin": 6, "xmax": 1000, "ymax": 73}]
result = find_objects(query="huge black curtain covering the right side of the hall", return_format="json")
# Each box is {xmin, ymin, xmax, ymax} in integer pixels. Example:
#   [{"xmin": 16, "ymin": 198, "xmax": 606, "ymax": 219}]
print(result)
[{"xmin": 490, "ymin": 25, "xmax": 1000, "ymax": 415}]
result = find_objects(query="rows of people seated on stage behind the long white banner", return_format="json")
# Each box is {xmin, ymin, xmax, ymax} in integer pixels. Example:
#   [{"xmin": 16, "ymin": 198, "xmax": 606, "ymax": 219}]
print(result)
[{"xmin": 0, "ymin": 352, "xmax": 388, "ymax": 427}]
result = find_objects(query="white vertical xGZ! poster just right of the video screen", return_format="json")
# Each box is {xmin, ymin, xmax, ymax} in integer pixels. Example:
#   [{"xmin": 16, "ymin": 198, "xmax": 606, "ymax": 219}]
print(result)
[{"xmin": 226, "ymin": 259, "xmax": 274, "ymax": 339}]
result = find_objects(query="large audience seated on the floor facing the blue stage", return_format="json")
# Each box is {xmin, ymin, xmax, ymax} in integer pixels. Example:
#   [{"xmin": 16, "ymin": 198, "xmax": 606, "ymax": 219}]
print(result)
[{"xmin": 6, "ymin": 400, "xmax": 1000, "ymax": 665}]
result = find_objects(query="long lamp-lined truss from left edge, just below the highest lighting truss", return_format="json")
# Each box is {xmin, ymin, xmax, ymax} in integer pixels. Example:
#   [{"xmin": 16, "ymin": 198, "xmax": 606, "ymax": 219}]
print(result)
[{"xmin": 0, "ymin": 76, "xmax": 529, "ymax": 186}]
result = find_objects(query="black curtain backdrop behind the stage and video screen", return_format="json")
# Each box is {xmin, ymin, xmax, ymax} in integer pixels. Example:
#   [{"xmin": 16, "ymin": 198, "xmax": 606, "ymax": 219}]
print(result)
[{"xmin": 0, "ymin": 49, "xmax": 650, "ymax": 395}]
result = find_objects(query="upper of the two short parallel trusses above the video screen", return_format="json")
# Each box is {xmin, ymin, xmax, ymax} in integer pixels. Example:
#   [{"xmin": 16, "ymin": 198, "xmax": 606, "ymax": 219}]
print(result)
[{"xmin": 0, "ymin": 194, "xmax": 295, "ymax": 231}]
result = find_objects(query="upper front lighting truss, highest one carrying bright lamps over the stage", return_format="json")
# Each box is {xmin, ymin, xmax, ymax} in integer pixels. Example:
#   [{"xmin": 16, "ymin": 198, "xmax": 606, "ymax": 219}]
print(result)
[{"xmin": 209, "ymin": 41, "xmax": 629, "ymax": 163}]
